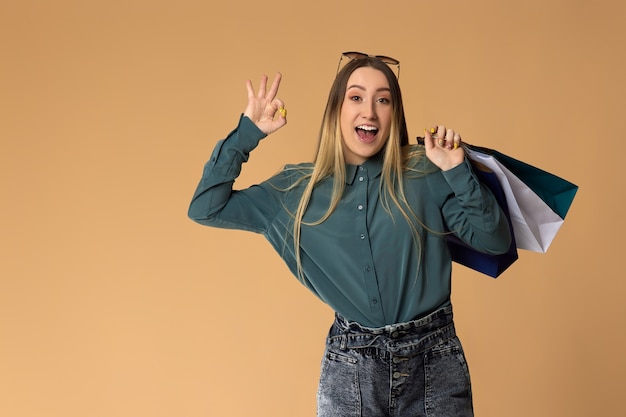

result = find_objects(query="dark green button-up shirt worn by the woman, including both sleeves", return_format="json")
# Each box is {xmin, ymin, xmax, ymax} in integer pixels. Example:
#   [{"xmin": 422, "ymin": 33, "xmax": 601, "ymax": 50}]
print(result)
[{"xmin": 189, "ymin": 117, "xmax": 510, "ymax": 327}]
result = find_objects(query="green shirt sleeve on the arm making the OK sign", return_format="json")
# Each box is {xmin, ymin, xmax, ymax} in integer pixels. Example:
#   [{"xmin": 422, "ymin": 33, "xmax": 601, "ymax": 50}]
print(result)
[{"xmin": 188, "ymin": 115, "xmax": 280, "ymax": 233}]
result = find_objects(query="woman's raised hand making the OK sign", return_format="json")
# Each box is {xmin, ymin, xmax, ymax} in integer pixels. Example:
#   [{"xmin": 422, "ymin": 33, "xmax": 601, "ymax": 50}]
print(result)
[{"xmin": 244, "ymin": 73, "xmax": 287, "ymax": 135}]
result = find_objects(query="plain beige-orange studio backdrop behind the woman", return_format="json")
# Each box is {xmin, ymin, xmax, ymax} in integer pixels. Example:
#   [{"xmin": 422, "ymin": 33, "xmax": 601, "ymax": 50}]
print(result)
[{"xmin": 0, "ymin": 0, "xmax": 626, "ymax": 417}]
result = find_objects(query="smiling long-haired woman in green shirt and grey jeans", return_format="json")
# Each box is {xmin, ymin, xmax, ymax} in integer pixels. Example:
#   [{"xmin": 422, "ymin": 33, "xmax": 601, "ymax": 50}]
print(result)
[{"xmin": 189, "ymin": 54, "xmax": 510, "ymax": 417}]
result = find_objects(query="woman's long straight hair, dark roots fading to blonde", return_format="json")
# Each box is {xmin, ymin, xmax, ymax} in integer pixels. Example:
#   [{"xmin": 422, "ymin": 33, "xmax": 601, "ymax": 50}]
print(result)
[{"xmin": 286, "ymin": 57, "xmax": 423, "ymax": 279}]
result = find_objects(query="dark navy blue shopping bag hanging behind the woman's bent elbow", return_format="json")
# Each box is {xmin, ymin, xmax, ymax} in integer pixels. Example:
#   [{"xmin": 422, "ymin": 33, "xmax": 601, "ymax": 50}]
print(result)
[{"xmin": 447, "ymin": 164, "xmax": 518, "ymax": 278}]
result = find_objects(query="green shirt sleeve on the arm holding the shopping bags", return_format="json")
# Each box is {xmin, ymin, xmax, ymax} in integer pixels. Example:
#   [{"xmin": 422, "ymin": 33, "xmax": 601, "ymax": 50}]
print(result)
[{"xmin": 431, "ymin": 159, "xmax": 511, "ymax": 254}]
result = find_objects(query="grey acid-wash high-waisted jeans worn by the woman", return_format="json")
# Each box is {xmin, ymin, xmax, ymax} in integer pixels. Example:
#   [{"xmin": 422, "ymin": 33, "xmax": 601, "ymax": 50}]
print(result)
[{"xmin": 317, "ymin": 306, "xmax": 474, "ymax": 417}]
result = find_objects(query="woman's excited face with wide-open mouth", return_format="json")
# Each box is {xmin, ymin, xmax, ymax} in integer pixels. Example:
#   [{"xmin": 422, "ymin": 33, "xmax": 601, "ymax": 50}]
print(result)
[{"xmin": 340, "ymin": 67, "xmax": 392, "ymax": 165}]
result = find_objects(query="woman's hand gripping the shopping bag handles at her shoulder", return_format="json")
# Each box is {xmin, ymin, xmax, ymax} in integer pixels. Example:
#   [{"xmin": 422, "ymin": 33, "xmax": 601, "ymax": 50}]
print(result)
[{"xmin": 424, "ymin": 126, "xmax": 465, "ymax": 171}]
